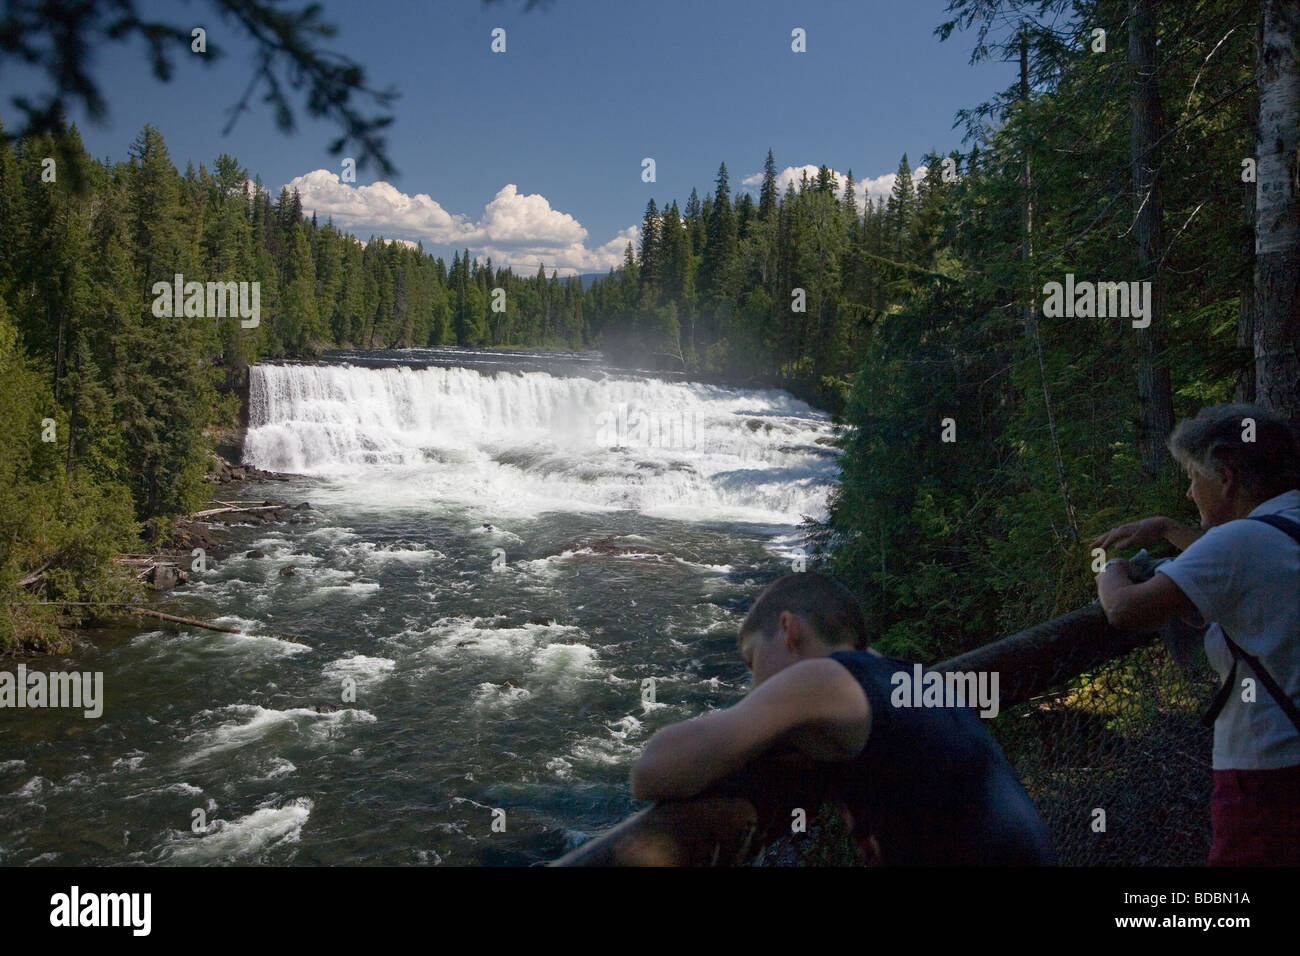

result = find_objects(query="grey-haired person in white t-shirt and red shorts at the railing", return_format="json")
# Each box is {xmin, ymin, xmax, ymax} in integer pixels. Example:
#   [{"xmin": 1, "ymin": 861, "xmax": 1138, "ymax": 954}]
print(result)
[{"xmin": 1092, "ymin": 405, "xmax": 1300, "ymax": 866}]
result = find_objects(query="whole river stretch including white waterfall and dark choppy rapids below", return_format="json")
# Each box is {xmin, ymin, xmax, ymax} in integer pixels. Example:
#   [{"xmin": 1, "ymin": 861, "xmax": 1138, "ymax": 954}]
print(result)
[{"xmin": 0, "ymin": 351, "xmax": 837, "ymax": 865}]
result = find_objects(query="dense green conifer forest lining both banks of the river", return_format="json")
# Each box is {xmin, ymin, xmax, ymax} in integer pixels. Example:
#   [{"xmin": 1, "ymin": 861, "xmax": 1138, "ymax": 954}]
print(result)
[{"xmin": 0, "ymin": 0, "xmax": 1300, "ymax": 659}]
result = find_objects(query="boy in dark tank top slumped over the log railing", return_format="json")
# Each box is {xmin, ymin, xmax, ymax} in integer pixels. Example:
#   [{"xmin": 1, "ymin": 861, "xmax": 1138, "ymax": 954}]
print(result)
[{"xmin": 632, "ymin": 572, "xmax": 1056, "ymax": 865}]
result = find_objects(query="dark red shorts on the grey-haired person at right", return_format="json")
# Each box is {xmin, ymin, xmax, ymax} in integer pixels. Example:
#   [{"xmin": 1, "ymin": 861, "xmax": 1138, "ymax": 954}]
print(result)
[{"xmin": 1209, "ymin": 765, "xmax": 1300, "ymax": 866}]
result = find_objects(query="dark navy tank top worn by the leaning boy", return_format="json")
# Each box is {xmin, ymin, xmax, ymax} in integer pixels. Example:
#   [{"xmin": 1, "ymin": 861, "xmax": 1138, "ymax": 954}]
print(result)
[{"xmin": 831, "ymin": 650, "xmax": 1057, "ymax": 866}]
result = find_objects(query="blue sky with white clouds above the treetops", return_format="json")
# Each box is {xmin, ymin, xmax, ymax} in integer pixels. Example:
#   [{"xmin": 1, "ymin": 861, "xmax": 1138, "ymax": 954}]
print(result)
[{"xmin": 0, "ymin": 0, "xmax": 1015, "ymax": 274}]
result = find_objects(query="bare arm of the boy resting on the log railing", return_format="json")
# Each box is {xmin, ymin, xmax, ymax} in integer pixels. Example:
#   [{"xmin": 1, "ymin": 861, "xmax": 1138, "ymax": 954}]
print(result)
[{"xmin": 632, "ymin": 658, "xmax": 871, "ymax": 800}]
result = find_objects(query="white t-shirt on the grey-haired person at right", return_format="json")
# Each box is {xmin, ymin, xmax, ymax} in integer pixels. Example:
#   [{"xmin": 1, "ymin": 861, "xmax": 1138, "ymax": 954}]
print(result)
[{"xmin": 1157, "ymin": 490, "xmax": 1300, "ymax": 770}]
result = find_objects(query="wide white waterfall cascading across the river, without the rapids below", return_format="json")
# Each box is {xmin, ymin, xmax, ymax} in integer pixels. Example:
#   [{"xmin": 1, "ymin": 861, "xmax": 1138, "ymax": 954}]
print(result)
[{"xmin": 244, "ymin": 365, "xmax": 839, "ymax": 525}]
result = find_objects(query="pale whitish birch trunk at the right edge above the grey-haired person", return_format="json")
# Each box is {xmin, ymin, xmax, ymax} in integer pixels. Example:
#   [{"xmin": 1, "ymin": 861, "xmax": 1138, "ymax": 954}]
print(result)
[{"xmin": 1255, "ymin": 0, "xmax": 1300, "ymax": 425}]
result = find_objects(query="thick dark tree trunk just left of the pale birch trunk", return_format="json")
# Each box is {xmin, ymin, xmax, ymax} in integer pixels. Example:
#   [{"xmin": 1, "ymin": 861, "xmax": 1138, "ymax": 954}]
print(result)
[{"xmin": 1128, "ymin": 0, "xmax": 1174, "ymax": 477}]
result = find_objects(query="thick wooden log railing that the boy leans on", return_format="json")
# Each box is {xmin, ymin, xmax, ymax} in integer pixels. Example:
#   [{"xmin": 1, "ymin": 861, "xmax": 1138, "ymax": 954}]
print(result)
[{"xmin": 551, "ymin": 604, "xmax": 1157, "ymax": 866}]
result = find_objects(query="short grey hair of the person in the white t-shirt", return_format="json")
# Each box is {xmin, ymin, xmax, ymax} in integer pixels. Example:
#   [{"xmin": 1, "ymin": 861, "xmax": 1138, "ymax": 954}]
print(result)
[{"xmin": 1169, "ymin": 405, "xmax": 1300, "ymax": 501}]
